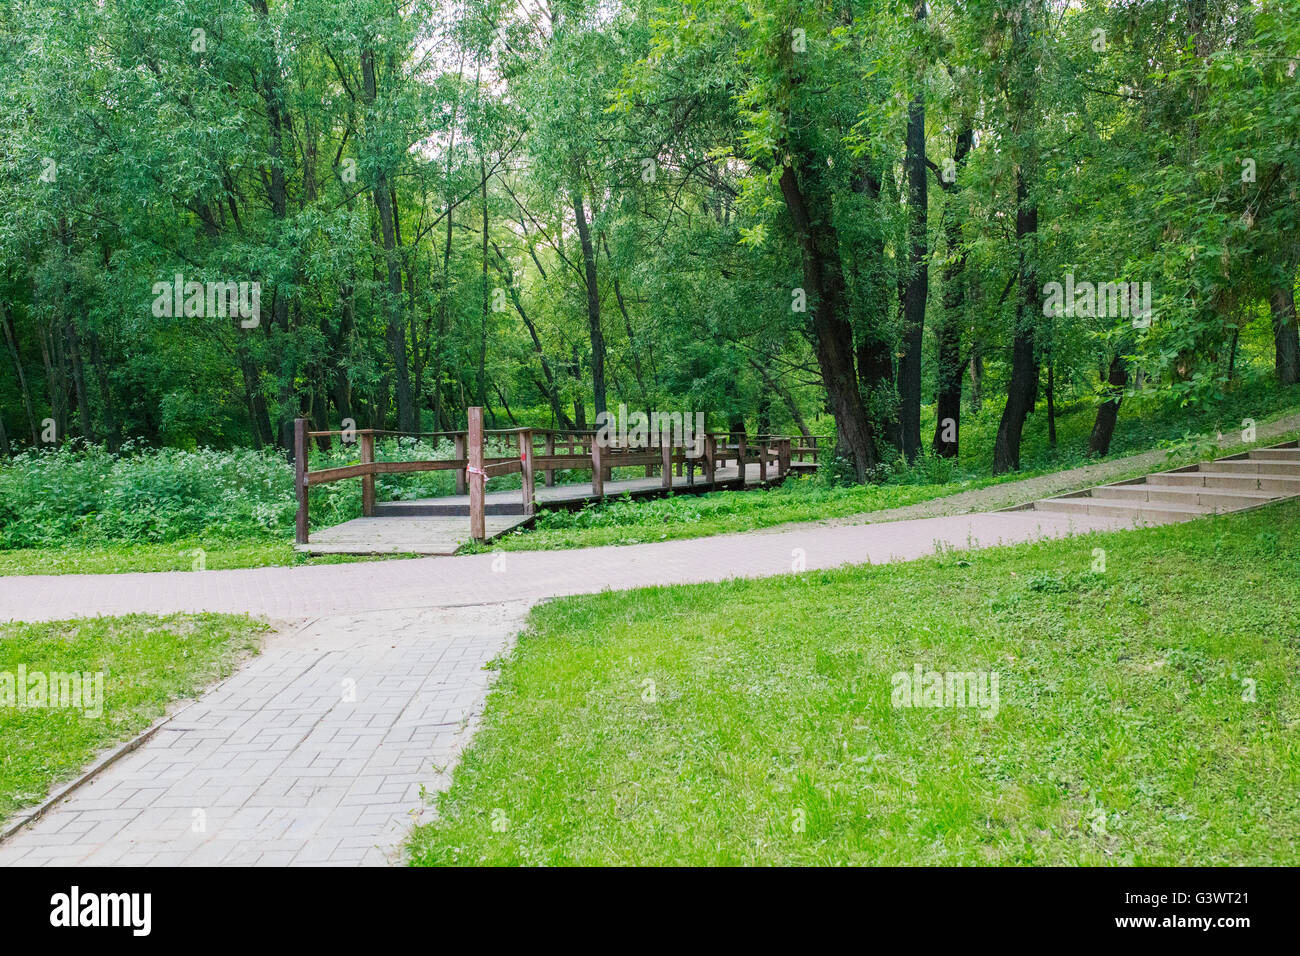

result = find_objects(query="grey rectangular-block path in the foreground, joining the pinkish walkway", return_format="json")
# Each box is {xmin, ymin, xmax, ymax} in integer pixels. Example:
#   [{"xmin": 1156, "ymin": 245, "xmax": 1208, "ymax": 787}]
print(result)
[{"xmin": 0, "ymin": 602, "xmax": 528, "ymax": 866}]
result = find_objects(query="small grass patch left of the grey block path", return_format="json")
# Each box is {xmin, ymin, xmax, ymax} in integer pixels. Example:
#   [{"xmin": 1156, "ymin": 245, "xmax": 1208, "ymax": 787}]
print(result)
[{"xmin": 0, "ymin": 614, "xmax": 267, "ymax": 821}]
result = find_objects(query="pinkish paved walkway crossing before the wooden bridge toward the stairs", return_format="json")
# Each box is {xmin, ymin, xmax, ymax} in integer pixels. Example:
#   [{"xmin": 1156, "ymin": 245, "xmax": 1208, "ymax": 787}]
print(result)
[{"xmin": 0, "ymin": 511, "xmax": 1119, "ymax": 622}]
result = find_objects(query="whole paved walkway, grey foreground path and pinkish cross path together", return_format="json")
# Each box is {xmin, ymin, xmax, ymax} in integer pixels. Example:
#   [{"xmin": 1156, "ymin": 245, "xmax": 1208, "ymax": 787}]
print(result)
[{"xmin": 0, "ymin": 511, "xmax": 1119, "ymax": 865}]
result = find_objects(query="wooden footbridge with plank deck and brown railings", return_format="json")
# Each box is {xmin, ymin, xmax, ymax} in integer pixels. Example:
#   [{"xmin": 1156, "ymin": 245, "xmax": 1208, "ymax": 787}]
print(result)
[{"xmin": 294, "ymin": 407, "xmax": 828, "ymax": 554}]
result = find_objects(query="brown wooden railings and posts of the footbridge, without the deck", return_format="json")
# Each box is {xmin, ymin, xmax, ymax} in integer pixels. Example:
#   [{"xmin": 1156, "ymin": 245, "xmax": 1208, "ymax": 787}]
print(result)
[{"xmin": 294, "ymin": 407, "xmax": 826, "ymax": 545}]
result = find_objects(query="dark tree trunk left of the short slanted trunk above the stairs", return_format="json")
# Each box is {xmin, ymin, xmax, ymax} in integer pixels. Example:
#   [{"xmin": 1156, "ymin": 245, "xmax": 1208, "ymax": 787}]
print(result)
[{"xmin": 993, "ymin": 169, "xmax": 1043, "ymax": 475}]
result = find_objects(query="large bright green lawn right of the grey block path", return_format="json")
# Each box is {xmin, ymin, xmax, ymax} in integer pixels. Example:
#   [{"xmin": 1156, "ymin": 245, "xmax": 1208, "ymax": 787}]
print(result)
[{"xmin": 411, "ymin": 503, "xmax": 1300, "ymax": 865}]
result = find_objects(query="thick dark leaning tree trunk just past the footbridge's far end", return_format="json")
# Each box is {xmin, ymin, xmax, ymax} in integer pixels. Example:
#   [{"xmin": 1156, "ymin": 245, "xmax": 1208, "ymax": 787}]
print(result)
[{"xmin": 781, "ymin": 160, "xmax": 879, "ymax": 481}]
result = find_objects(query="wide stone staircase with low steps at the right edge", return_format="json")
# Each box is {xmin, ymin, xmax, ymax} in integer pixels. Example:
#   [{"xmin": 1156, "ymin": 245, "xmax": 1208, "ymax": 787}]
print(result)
[{"xmin": 1008, "ymin": 441, "xmax": 1300, "ymax": 525}]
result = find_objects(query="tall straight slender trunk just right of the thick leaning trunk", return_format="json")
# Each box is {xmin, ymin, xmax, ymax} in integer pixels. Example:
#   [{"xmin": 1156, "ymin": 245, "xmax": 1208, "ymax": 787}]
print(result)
[{"xmin": 898, "ymin": 0, "xmax": 930, "ymax": 462}]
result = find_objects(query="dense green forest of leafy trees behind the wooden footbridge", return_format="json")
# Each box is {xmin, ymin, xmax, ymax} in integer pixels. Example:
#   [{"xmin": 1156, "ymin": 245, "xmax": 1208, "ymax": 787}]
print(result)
[{"xmin": 0, "ymin": 0, "xmax": 1300, "ymax": 481}]
